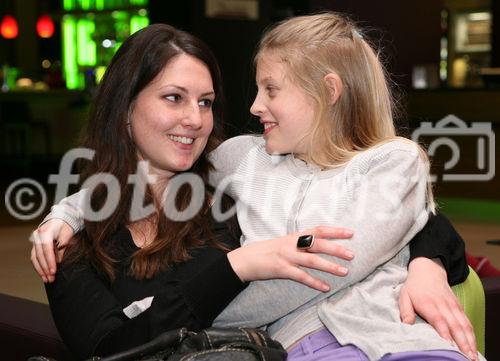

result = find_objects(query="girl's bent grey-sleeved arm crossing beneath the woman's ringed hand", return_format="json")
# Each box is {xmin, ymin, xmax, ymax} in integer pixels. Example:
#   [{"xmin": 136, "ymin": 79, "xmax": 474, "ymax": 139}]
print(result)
[{"xmin": 214, "ymin": 142, "xmax": 428, "ymax": 327}]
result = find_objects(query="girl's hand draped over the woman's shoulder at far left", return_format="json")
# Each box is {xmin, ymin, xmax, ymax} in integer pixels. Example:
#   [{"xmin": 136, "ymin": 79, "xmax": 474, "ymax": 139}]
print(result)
[{"xmin": 30, "ymin": 218, "xmax": 73, "ymax": 283}]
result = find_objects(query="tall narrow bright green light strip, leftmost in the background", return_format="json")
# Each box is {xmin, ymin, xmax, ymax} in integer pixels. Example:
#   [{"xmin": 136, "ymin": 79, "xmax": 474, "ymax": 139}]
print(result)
[{"xmin": 62, "ymin": 15, "xmax": 79, "ymax": 89}]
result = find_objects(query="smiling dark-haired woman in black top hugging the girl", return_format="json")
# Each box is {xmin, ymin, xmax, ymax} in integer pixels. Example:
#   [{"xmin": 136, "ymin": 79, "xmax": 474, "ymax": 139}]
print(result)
[{"xmin": 32, "ymin": 25, "xmax": 472, "ymax": 358}]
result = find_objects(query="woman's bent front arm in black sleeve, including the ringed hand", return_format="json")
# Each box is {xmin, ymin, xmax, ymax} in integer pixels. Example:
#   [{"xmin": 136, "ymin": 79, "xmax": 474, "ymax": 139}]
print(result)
[{"xmin": 46, "ymin": 223, "xmax": 350, "ymax": 358}]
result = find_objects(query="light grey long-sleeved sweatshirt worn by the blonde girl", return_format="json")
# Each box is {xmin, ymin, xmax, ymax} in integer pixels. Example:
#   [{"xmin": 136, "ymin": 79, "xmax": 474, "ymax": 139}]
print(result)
[{"xmin": 211, "ymin": 136, "xmax": 466, "ymax": 360}]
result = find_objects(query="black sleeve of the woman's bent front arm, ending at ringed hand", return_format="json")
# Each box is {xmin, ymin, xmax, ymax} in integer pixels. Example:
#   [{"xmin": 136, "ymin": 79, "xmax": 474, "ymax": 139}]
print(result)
[{"xmin": 46, "ymin": 248, "xmax": 246, "ymax": 359}]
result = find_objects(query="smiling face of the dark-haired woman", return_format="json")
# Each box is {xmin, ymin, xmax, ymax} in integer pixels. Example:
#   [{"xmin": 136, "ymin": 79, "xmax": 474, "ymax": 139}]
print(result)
[{"xmin": 130, "ymin": 54, "xmax": 215, "ymax": 178}]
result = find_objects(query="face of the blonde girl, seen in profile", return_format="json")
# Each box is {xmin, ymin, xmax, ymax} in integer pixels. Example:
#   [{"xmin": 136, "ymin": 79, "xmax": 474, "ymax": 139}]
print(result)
[{"xmin": 250, "ymin": 53, "xmax": 315, "ymax": 156}]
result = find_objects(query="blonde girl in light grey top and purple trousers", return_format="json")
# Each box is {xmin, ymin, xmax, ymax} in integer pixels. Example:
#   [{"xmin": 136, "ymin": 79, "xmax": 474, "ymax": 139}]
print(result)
[{"xmin": 208, "ymin": 13, "xmax": 477, "ymax": 361}]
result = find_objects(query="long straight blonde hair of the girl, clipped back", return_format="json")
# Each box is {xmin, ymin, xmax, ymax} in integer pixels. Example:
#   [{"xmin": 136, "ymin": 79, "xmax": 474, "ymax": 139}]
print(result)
[{"xmin": 255, "ymin": 12, "xmax": 434, "ymax": 209}]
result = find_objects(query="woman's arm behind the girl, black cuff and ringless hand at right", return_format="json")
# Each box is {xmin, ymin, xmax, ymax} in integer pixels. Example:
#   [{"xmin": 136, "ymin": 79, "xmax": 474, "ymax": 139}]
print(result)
[{"xmin": 399, "ymin": 214, "xmax": 476, "ymax": 355}]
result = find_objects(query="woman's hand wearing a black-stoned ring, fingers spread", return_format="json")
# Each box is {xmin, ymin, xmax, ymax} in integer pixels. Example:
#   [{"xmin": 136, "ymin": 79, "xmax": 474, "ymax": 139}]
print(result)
[{"xmin": 228, "ymin": 227, "xmax": 354, "ymax": 292}]
